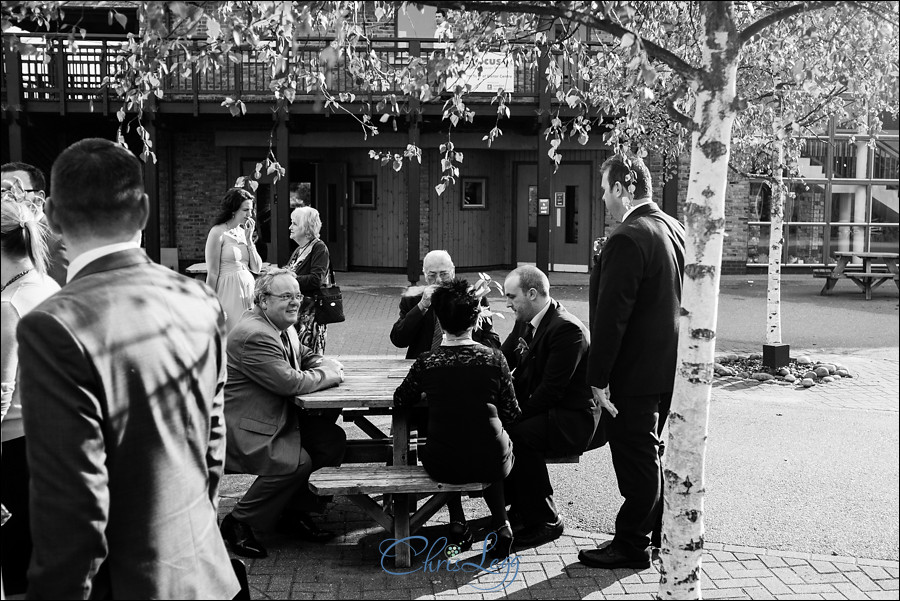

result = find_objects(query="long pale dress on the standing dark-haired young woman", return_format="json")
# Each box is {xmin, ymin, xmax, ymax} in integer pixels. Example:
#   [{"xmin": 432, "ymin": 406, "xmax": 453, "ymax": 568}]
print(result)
[{"xmin": 216, "ymin": 228, "xmax": 254, "ymax": 332}]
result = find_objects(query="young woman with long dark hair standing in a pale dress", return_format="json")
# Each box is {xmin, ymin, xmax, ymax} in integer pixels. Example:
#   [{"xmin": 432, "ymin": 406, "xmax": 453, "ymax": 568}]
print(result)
[{"xmin": 206, "ymin": 188, "xmax": 262, "ymax": 332}]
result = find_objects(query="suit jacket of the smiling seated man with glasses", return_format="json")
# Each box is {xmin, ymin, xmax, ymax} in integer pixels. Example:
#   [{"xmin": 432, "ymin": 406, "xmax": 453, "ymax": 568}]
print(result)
[{"xmin": 225, "ymin": 307, "xmax": 340, "ymax": 476}]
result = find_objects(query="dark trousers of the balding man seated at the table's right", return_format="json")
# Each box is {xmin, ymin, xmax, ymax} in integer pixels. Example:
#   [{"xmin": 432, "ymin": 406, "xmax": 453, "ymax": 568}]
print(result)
[{"xmin": 505, "ymin": 413, "xmax": 559, "ymax": 526}]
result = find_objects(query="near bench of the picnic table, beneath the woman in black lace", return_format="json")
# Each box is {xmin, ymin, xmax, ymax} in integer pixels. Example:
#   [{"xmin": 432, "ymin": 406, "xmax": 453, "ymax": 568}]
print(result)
[{"xmin": 309, "ymin": 465, "xmax": 490, "ymax": 568}]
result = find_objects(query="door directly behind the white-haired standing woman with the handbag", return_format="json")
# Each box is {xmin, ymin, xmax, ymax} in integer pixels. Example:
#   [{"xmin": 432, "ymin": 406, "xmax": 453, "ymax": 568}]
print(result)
[{"xmin": 315, "ymin": 162, "xmax": 347, "ymax": 271}]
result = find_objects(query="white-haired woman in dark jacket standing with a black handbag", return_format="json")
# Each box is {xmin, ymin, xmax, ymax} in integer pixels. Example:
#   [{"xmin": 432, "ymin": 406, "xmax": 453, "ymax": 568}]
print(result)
[{"xmin": 286, "ymin": 207, "xmax": 331, "ymax": 355}]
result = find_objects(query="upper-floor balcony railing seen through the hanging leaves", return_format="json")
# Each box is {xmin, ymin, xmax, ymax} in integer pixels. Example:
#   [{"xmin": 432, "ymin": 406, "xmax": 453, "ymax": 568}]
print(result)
[{"xmin": 2, "ymin": 34, "xmax": 599, "ymax": 114}]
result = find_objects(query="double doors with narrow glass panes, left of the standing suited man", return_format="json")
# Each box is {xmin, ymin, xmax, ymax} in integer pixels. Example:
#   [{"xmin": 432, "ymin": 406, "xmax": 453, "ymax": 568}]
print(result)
[{"xmin": 516, "ymin": 163, "xmax": 591, "ymax": 272}]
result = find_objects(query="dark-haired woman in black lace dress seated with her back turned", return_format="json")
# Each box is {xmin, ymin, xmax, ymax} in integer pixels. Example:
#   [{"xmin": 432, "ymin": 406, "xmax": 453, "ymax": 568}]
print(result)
[{"xmin": 394, "ymin": 279, "xmax": 522, "ymax": 559}]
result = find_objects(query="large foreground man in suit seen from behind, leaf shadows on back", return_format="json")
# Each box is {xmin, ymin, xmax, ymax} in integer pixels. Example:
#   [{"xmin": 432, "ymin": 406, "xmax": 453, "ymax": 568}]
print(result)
[{"xmin": 17, "ymin": 138, "xmax": 239, "ymax": 599}]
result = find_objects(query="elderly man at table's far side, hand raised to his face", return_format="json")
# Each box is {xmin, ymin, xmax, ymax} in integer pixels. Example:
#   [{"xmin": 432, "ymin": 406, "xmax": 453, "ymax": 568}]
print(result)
[{"xmin": 391, "ymin": 250, "xmax": 500, "ymax": 359}]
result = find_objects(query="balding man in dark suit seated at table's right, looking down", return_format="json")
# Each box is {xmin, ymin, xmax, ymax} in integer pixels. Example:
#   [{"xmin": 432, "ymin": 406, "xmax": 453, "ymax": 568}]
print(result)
[{"xmin": 502, "ymin": 265, "xmax": 600, "ymax": 547}]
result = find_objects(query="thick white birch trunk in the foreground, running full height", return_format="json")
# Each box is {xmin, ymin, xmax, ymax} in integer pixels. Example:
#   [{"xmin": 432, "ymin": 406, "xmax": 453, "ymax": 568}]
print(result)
[{"xmin": 660, "ymin": 2, "xmax": 740, "ymax": 599}]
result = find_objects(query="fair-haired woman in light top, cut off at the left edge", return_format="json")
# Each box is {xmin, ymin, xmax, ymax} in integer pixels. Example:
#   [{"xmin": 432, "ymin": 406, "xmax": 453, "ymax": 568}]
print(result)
[{"xmin": 0, "ymin": 197, "xmax": 59, "ymax": 595}]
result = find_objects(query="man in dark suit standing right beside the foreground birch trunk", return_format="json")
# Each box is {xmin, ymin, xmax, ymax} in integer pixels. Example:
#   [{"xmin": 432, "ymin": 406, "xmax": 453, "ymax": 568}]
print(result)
[{"xmin": 578, "ymin": 155, "xmax": 684, "ymax": 569}]
